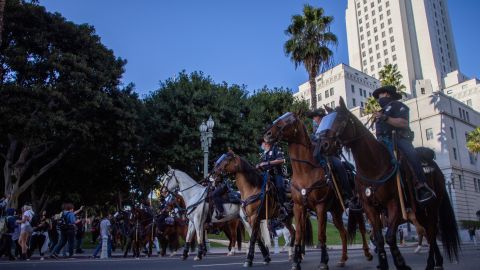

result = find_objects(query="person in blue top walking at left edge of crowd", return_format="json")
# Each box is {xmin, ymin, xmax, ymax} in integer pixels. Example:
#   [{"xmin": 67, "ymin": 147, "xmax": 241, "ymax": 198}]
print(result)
[{"xmin": 50, "ymin": 203, "xmax": 76, "ymax": 259}]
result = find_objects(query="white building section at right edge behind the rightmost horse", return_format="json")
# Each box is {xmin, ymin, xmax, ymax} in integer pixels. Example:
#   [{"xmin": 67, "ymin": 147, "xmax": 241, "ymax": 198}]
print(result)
[{"xmin": 346, "ymin": 90, "xmax": 480, "ymax": 221}]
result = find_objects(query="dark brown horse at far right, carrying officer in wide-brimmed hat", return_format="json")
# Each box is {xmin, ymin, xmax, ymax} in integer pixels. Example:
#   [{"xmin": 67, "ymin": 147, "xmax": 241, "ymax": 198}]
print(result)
[{"xmin": 320, "ymin": 98, "xmax": 459, "ymax": 269}]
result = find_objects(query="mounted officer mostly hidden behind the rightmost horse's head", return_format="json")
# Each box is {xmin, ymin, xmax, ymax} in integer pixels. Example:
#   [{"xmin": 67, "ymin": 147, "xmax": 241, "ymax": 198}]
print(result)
[{"xmin": 307, "ymin": 108, "xmax": 360, "ymax": 210}]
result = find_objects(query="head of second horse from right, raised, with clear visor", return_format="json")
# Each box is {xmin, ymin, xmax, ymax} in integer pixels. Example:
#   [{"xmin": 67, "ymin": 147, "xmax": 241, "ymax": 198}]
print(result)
[{"xmin": 263, "ymin": 112, "xmax": 310, "ymax": 145}]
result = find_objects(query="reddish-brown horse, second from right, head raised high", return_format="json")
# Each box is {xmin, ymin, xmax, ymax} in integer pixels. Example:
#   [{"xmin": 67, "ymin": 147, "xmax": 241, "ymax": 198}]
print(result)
[{"xmin": 264, "ymin": 113, "xmax": 372, "ymax": 269}]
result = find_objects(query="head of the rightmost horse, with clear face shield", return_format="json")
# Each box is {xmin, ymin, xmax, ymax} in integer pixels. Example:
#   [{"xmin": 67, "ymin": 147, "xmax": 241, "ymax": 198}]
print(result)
[{"xmin": 317, "ymin": 97, "xmax": 363, "ymax": 155}]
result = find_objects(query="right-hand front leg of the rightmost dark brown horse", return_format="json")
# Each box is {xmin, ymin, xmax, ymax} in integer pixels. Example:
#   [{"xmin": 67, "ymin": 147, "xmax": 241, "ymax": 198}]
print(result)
[{"xmin": 386, "ymin": 201, "xmax": 411, "ymax": 270}]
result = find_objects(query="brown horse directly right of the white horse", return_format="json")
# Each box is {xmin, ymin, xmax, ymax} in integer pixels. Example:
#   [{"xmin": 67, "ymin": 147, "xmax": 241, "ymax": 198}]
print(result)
[{"xmin": 213, "ymin": 150, "xmax": 295, "ymax": 267}]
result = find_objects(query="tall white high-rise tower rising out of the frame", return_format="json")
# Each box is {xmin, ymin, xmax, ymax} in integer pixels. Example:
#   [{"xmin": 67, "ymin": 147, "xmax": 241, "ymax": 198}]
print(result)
[{"xmin": 345, "ymin": 0, "xmax": 458, "ymax": 95}]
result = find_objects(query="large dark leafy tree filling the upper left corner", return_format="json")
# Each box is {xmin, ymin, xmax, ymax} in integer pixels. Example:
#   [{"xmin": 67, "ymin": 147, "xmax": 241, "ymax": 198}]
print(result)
[{"xmin": 0, "ymin": 1, "xmax": 137, "ymax": 207}]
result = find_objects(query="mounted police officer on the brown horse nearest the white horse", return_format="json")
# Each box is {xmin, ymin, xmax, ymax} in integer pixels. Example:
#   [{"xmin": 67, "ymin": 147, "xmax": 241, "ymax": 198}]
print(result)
[{"xmin": 256, "ymin": 140, "xmax": 286, "ymax": 219}]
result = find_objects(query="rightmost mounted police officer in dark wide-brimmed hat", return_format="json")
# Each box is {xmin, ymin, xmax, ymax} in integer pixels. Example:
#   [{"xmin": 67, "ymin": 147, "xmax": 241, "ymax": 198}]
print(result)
[{"xmin": 373, "ymin": 86, "xmax": 435, "ymax": 203}]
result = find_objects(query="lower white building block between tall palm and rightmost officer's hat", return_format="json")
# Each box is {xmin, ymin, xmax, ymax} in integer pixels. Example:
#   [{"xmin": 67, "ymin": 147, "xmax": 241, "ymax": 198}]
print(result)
[{"xmin": 294, "ymin": 64, "xmax": 380, "ymax": 109}]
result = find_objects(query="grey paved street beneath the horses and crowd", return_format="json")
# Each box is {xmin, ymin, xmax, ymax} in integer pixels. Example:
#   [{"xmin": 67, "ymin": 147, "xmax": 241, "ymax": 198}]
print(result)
[{"xmin": 0, "ymin": 245, "xmax": 480, "ymax": 270}]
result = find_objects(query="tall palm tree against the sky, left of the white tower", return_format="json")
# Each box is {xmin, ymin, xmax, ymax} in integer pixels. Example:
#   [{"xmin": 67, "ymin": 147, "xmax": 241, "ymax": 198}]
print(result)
[{"xmin": 284, "ymin": 5, "xmax": 337, "ymax": 108}]
